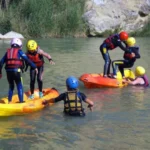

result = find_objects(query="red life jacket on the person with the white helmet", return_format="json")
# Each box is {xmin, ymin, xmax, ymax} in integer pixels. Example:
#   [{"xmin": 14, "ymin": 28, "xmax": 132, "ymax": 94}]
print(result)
[{"xmin": 5, "ymin": 48, "xmax": 23, "ymax": 69}]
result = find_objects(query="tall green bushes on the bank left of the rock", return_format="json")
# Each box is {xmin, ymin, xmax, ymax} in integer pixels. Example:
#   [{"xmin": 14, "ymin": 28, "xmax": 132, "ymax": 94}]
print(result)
[{"xmin": 0, "ymin": 0, "xmax": 85, "ymax": 37}]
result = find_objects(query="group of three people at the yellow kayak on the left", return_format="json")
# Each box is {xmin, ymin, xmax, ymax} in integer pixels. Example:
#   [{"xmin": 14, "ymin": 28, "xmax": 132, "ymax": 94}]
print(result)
[{"xmin": 0, "ymin": 38, "xmax": 94, "ymax": 116}]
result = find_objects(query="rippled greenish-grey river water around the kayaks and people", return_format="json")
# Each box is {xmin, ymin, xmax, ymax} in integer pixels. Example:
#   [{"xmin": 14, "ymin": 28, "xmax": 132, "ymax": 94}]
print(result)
[{"xmin": 0, "ymin": 38, "xmax": 150, "ymax": 150}]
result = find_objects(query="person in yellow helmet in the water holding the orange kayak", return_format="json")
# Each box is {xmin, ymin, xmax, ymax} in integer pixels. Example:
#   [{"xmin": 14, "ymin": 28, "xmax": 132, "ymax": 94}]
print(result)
[{"xmin": 123, "ymin": 66, "xmax": 149, "ymax": 87}]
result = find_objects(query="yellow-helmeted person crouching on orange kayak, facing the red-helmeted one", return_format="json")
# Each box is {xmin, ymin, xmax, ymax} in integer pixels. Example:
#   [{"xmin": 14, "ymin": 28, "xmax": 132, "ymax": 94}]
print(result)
[{"xmin": 112, "ymin": 37, "xmax": 140, "ymax": 78}]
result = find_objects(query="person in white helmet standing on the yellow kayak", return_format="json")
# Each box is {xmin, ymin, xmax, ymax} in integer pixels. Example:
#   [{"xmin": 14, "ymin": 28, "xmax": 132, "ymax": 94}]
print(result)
[{"xmin": 0, "ymin": 38, "xmax": 37, "ymax": 103}]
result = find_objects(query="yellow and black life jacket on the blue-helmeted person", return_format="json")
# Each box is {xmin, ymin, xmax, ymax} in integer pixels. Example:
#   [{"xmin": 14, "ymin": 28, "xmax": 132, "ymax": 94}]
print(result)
[{"xmin": 64, "ymin": 91, "xmax": 84, "ymax": 115}]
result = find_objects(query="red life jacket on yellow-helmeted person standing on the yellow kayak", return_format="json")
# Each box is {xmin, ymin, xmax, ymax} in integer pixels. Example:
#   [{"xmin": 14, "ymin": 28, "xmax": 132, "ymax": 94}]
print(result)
[{"xmin": 27, "ymin": 52, "xmax": 44, "ymax": 67}]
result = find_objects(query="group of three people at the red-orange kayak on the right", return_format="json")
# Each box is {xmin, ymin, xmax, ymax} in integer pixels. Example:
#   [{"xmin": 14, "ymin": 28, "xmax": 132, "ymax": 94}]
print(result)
[{"xmin": 100, "ymin": 31, "xmax": 149, "ymax": 86}]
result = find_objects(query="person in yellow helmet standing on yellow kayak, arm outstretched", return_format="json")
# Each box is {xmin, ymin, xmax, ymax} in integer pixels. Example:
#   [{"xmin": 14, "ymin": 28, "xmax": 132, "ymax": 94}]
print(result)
[{"xmin": 26, "ymin": 40, "xmax": 55, "ymax": 99}]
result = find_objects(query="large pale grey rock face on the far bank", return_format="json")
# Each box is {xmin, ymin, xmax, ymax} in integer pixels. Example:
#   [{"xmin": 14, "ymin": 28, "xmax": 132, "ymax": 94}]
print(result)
[{"xmin": 83, "ymin": 0, "xmax": 150, "ymax": 36}]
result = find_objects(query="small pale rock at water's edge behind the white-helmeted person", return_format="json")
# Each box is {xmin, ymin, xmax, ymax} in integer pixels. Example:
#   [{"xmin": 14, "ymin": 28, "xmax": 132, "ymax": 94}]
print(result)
[{"xmin": 0, "ymin": 31, "xmax": 24, "ymax": 39}]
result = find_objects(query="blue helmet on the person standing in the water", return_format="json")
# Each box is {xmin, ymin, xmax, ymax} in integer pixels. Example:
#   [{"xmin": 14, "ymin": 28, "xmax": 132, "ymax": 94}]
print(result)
[{"xmin": 66, "ymin": 76, "xmax": 79, "ymax": 89}]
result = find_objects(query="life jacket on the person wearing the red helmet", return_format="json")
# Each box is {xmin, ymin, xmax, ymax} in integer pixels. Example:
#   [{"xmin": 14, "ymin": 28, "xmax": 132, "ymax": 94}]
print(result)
[{"xmin": 104, "ymin": 34, "xmax": 119, "ymax": 50}]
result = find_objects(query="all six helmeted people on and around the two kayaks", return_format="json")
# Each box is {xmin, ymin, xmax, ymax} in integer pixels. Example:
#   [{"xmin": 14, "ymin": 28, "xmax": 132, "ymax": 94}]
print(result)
[{"xmin": 0, "ymin": 31, "xmax": 149, "ymax": 116}]
